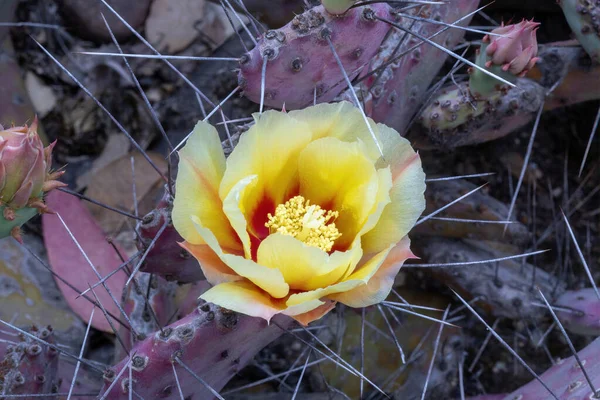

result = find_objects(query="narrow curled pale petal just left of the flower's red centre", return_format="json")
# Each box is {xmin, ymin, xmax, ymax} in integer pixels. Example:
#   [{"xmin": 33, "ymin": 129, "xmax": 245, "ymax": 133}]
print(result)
[{"xmin": 223, "ymin": 175, "xmax": 258, "ymax": 259}]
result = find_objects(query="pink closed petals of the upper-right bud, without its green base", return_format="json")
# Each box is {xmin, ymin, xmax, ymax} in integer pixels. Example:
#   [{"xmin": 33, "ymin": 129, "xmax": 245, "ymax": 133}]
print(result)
[{"xmin": 483, "ymin": 21, "xmax": 540, "ymax": 76}]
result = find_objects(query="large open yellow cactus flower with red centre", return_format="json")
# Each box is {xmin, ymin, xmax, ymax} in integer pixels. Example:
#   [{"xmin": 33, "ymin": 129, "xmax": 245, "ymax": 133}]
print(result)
[{"xmin": 173, "ymin": 102, "xmax": 425, "ymax": 325}]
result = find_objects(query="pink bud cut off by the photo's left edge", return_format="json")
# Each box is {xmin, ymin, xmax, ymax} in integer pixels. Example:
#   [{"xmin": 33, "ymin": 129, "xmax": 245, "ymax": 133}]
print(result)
[{"xmin": 0, "ymin": 119, "xmax": 65, "ymax": 240}]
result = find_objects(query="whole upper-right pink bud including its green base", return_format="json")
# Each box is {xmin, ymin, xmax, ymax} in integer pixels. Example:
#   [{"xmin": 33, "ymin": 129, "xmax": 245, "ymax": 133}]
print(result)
[{"xmin": 470, "ymin": 21, "xmax": 540, "ymax": 98}]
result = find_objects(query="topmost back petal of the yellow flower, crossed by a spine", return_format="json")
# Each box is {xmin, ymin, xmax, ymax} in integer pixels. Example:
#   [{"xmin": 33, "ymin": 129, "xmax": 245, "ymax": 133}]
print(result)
[{"xmin": 289, "ymin": 101, "xmax": 401, "ymax": 164}]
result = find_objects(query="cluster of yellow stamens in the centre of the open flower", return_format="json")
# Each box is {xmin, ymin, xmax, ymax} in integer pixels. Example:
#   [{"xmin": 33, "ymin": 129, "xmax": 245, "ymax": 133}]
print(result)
[{"xmin": 265, "ymin": 196, "xmax": 342, "ymax": 251}]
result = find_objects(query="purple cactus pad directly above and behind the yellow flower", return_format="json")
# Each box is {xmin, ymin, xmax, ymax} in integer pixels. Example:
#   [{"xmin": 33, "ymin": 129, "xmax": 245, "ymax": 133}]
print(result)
[{"xmin": 238, "ymin": 3, "xmax": 394, "ymax": 110}]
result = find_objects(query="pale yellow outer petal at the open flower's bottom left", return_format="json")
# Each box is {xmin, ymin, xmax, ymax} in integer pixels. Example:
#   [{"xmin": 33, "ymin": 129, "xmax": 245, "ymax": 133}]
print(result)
[{"xmin": 200, "ymin": 281, "xmax": 285, "ymax": 321}]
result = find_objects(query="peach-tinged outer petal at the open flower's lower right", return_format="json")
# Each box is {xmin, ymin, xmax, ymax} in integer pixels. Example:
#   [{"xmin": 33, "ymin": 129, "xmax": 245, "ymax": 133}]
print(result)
[{"xmin": 328, "ymin": 237, "xmax": 415, "ymax": 308}]
